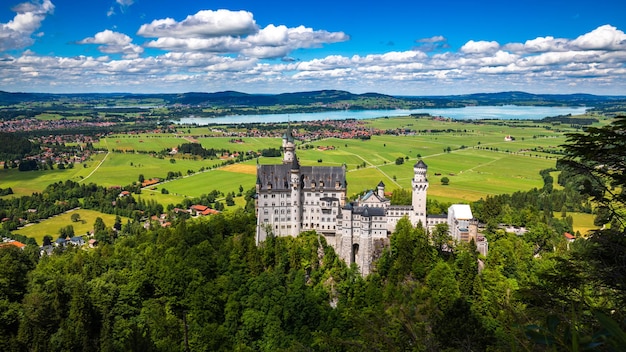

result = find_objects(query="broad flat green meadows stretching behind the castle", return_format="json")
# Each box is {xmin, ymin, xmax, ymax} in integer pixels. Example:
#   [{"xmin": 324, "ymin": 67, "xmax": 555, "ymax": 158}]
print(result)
[{"xmin": 0, "ymin": 117, "xmax": 588, "ymax": 205}]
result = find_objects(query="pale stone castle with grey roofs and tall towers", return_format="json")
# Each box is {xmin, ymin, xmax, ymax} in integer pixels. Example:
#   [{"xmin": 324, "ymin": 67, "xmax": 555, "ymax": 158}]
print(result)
[{"xmin": 256, "ymin": 127, "xmax": 486, "ymax": 275}]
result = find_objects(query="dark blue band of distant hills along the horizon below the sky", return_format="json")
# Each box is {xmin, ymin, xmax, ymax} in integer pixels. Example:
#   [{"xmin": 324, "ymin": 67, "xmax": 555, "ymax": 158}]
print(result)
[{"xmin": 0, "ymin": 90, "xmax": 626, "ymax": 109}]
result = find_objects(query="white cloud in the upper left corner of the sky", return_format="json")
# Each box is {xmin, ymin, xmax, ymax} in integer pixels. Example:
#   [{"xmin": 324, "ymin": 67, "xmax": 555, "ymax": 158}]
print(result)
[{"xmin": 0, "ymin": 0, "xmax": 54, "ymax": 52}]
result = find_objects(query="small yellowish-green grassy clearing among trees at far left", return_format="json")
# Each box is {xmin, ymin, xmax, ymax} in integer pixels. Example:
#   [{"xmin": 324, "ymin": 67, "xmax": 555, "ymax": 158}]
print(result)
[{"xmin": 13, "ymin": 209, "xmax": 130, "ymax": 245}]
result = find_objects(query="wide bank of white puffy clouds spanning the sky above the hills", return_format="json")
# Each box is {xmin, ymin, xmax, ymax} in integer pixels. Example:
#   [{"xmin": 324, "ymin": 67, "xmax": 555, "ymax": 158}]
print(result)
[{"xmin": 0, "ymin": 13, "xmax": 626, "ymax": 95}]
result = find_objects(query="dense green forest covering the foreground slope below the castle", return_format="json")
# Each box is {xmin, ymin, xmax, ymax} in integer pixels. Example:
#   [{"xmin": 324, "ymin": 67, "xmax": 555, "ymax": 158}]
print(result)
[{"xmin": 0, "ymin": 118, "xmax": 626, "ymax": 351}]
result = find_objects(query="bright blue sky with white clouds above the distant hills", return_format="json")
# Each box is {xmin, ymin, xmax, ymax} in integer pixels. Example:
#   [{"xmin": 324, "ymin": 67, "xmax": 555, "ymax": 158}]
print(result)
[{"xmin": 0, "ymin": 0, "xmax": 626, "ymax": 95}]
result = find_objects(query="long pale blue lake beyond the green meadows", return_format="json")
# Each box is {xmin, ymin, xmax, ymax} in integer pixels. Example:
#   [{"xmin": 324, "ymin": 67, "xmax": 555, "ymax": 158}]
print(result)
[{"xmin": 174, "ymin": 105, "xmax": 587, "ymax": 126}]
